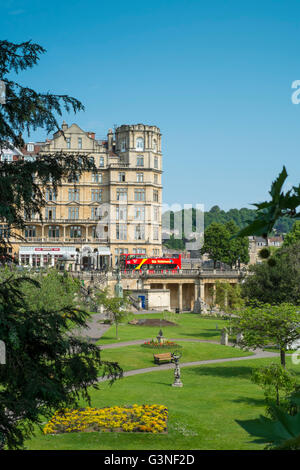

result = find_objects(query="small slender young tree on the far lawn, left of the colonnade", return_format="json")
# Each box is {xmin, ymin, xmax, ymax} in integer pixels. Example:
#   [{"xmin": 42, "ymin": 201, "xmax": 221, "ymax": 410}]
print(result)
[{"xmin": 95, "ymin": 289, "xmax": 129, "ymax": 339}]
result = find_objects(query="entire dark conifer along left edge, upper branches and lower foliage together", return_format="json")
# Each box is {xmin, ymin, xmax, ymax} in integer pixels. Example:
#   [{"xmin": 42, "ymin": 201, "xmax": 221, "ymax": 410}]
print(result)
[{"xmin": 0, "ymin": 41, "xmax": 122, "ymax": 448}]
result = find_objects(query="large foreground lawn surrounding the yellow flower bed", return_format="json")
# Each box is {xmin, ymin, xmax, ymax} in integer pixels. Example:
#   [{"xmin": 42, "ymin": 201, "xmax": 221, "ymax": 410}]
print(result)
[{"xmin": 26, "ymin": 358, "xmax": 299, "ymax": 450}]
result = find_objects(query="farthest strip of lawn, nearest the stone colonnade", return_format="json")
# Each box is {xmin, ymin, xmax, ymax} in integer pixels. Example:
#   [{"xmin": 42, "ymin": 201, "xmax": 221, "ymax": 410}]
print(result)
[{"xmin": 98, "ymin": 313, "xmax": 229, "ymax": 345}]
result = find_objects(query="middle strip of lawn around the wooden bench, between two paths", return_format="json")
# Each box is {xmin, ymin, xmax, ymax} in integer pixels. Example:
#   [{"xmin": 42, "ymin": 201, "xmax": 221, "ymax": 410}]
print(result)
[{"xmin": 101, "ymin": 341, "xmax": 253, "ymax": 371}]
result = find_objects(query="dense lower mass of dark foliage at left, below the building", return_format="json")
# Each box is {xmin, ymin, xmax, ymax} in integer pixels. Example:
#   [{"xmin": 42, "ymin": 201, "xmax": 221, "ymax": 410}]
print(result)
[{"xmin": 0, "ymin": 273, "xmax": 122, "ymax": 449}]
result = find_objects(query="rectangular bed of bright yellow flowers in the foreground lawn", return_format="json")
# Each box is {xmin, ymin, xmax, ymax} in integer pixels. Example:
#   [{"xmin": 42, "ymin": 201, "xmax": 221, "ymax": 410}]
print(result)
[{"xmin": 43, "ymin": 405, "xmax": 168, "ymax": 434}]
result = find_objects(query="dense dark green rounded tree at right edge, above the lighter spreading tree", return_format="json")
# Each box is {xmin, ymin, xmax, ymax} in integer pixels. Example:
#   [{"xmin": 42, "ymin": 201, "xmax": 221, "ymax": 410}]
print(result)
[{"xmin": 242, "ymin": 242, "xmax": 300, "ymax": 305}]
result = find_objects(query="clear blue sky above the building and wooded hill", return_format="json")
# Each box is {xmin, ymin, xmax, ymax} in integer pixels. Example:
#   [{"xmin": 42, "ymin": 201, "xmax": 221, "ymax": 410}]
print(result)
[{"xmin": 0, "ymin": 0, "xmax": 300, "ymax": 210}]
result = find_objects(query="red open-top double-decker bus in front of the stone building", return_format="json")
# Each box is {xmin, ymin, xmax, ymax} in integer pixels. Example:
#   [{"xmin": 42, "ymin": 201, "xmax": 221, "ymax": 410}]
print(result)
[{"xmin": 120, "ymin": 253, "xmax": 181, "ymax": 271}]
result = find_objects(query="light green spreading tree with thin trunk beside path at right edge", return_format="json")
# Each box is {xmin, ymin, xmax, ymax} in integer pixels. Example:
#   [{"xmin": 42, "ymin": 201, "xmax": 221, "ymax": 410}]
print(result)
[{"xmin": 232, "ymin": 303, "xmax": 300, "ymax": 367}]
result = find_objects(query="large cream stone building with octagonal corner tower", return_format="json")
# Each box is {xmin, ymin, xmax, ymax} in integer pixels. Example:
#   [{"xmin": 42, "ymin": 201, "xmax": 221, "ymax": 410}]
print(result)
[{"xmin": 3, "ymin": 122, "xmax": 162, "ymax": 269}]
